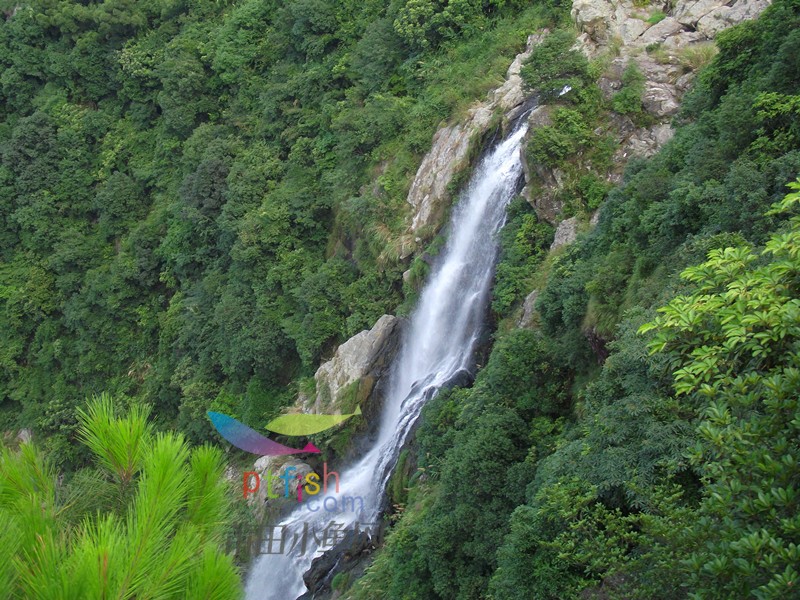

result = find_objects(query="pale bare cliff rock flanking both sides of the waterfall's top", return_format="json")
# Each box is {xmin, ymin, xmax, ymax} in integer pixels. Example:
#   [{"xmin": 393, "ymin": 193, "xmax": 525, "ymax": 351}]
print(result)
[{"xmin": 402, "ymin": 0, "xmax": 769, "ymax": 239}]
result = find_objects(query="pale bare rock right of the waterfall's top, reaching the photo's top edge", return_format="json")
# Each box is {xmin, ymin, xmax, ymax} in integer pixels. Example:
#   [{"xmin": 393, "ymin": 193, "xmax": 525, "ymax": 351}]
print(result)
[{"xmin": 522, "ymin": 0, "xmax": 769, "ymax": 227}]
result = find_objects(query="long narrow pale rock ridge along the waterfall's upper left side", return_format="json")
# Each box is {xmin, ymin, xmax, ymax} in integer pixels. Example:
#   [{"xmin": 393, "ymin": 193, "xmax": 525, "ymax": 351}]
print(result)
[{"xmin": 403, "ymin": 32, "xmax": 545, "ymax": 237}]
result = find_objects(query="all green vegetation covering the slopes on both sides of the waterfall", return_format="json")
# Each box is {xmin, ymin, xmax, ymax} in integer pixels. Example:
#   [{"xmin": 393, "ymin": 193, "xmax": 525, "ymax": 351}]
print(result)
[{"xmin": 0, "ymin": 0, "xmax": 800, "ymax": 600}]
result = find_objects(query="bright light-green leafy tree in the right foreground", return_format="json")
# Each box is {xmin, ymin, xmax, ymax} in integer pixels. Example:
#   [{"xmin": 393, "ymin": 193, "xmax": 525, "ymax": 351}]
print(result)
[{"xmin": 642, "ymin": 182, "xmax": 800, "ymax": 598}]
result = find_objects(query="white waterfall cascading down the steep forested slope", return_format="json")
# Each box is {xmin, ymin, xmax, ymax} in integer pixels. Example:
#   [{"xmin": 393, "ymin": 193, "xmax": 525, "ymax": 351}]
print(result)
[{"xmin": 246, "ymin": 119, "xmax": 527, "ymax": 600}]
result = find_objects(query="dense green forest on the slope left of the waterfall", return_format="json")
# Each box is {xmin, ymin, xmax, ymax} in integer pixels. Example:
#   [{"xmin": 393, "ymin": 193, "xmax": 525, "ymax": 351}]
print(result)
[{"xmin": 0, "ymin": 0, "xmax": 550, "ymax": 466}]
